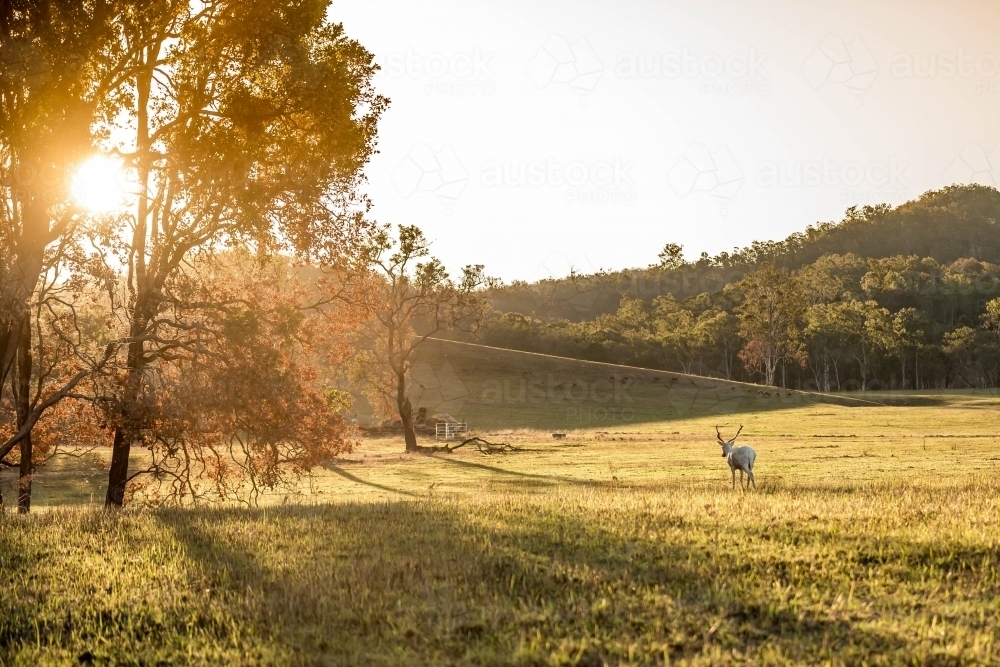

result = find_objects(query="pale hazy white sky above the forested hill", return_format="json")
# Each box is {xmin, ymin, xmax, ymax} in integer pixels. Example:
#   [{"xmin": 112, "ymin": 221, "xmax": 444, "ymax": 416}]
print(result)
[{"xmin": 332, "ymin": 0, "xmax": 1000, "ymax": 280}]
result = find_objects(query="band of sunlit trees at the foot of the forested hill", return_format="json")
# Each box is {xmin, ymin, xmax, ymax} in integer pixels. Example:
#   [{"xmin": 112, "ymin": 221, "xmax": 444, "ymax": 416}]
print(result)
[{"xmin": 485, "ymin": 249, "xmax": 1000, "ymax": 392}]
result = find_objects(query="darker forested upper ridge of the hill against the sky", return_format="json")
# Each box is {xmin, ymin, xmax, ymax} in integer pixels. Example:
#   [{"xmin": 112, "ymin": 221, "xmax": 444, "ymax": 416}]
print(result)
[{"xmin": 489, "ymin": 185, "xmax": 1000, "ymax": 321}]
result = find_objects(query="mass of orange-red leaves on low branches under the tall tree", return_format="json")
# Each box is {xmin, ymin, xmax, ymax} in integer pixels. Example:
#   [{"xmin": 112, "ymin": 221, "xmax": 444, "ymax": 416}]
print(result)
[{"xmin": 124, "ymin": 253, "xmax": 355, "ymax": 502}]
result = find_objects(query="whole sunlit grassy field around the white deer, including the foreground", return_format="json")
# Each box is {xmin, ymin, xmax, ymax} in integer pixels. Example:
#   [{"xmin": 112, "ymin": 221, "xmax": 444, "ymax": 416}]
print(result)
[{"xmin": 0, "ymin": 342, "xmax": 1000, "ymax": 665}]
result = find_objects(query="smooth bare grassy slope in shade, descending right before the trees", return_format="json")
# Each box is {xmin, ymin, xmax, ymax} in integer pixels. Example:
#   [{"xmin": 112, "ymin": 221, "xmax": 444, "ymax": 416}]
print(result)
[{"xmin": 348, "ymin": 340, "xmax": 878, "ymax": 430}]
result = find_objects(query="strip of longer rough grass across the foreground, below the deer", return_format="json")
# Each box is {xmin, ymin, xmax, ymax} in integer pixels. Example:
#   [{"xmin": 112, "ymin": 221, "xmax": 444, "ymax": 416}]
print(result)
[{"xmin": 0, "ymin": 480, "xmax": 1000, "ymax": 665}]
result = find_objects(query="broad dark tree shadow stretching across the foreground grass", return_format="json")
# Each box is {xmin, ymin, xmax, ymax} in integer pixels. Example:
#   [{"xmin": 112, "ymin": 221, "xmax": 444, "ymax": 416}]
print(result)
[{"xmin": 145, "ymin": 502, "xmax": 916, "ymax": 665}]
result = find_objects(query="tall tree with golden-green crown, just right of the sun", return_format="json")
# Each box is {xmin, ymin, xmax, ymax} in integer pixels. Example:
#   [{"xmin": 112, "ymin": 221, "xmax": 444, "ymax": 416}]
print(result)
[{"xmin": 93, "ymin": 0, "xmax": 387, "ymax": 506}]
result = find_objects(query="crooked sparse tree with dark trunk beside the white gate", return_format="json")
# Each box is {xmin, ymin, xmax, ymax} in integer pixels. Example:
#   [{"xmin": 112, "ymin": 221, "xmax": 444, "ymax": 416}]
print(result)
[{"xmin": 357, "ymin": 225, "xmax": 496, "ymax": 452}]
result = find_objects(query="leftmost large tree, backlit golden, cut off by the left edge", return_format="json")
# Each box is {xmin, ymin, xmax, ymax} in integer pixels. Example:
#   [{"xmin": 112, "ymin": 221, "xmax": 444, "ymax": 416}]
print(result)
[{"xmin": 0, "ymin": 0, "xmax": 131, "ymax": 510}]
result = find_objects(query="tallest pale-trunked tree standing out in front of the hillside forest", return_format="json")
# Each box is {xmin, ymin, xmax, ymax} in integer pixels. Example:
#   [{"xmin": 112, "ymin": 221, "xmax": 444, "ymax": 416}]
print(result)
[{"xmin": 737, "ymin": 264, "xmax": 807, "ymax": 386}]
